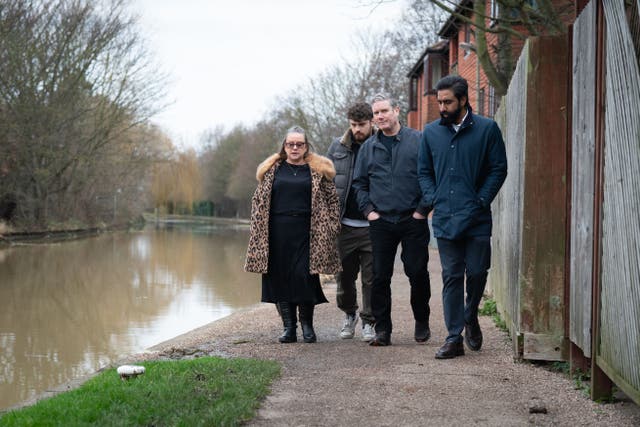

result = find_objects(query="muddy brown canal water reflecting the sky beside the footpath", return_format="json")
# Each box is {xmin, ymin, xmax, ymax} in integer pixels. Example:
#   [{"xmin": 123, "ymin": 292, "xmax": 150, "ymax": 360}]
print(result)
[{"xmin": 0, "ymin": 226, "xmax": 260, "ymax": 409}]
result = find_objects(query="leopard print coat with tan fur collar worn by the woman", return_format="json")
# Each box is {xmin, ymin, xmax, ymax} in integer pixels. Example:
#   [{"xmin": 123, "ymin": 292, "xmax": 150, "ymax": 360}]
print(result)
[{"xmin": 244, "ymin": 153, "xmax": 341, "ymax": 274}]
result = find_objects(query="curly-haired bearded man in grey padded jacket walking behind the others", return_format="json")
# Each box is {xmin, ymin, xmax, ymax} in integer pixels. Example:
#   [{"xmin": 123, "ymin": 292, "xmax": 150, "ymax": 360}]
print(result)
[{"xmin": 327, "ymin": 102, "xmax": 375, "ymax": 341}]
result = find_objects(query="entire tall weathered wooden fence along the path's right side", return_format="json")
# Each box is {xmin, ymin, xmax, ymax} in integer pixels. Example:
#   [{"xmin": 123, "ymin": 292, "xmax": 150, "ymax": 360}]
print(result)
[{"xmin": 489, "ymin": 0, "xmax": 640, "ymax": 404}]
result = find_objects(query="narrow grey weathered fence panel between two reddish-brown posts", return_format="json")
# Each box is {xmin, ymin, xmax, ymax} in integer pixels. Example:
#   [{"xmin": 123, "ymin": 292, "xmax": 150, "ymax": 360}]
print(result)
[{"xmin": 569, "ymin": 1, "xmax": 597, "ymax": 357}]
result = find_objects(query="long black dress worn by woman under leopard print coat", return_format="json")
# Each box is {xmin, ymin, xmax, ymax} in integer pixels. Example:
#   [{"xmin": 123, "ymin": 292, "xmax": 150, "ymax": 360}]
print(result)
[{"xmin": 262, "ymin": 161, "xmax": 328, "ymax": 305}]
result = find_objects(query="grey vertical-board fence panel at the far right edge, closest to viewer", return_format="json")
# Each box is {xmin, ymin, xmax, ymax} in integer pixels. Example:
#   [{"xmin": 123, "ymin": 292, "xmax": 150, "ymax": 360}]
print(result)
[{"xmin": 594, "ymin": 0, "xmax": 640, "ymax": 408}]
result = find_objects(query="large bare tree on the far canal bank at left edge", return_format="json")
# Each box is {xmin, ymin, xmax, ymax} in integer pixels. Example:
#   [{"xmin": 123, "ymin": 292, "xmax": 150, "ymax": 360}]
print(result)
[{"xmin": 0, "ymin": 0, "xmax": 168, "ymax": 227}]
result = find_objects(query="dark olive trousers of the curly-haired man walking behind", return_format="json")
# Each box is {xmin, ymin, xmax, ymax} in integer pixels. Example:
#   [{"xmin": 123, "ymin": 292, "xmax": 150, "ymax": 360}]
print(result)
[{"xmin": 336, "ymin": 225, "xmax": 375, "ymax": 324}]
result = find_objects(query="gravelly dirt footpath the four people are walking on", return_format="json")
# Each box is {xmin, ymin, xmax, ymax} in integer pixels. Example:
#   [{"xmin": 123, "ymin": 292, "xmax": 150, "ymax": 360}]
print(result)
[{"xmin": 147, "ymin": 250, "xmax": 640, "ymax": 426}]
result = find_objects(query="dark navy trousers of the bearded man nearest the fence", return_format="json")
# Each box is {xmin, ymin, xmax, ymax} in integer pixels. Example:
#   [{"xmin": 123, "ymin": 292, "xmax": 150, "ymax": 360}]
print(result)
[{"xmin": 438, "ymin": 236, "xmax": 491, "ymax": 342}]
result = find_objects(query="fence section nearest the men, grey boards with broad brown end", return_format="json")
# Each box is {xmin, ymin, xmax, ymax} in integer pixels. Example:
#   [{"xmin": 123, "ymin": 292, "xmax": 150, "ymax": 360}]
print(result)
[{"xmin": 490, "ymin": 36, "xmax": 568, "ymax": 360}]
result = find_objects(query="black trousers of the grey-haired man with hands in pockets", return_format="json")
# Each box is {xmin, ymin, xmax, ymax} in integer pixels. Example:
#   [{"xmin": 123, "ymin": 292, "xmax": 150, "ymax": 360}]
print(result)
[{"xmin": 369, "ymin": 218, "xmax": 431, "ymax": 333}]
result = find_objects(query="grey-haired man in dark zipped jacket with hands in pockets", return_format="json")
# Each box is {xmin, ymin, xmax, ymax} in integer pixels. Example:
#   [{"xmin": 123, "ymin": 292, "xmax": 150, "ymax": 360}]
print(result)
[{"xmin": 353, "ymin": 94, "xmax": 431, "ymax": 346}]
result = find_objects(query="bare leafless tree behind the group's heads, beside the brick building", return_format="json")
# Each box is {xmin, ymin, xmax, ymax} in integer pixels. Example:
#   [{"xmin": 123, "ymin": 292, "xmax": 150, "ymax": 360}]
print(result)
[{"xmin": 268, "ymin": 21, "xmax": 442, "ymax": 153}]
